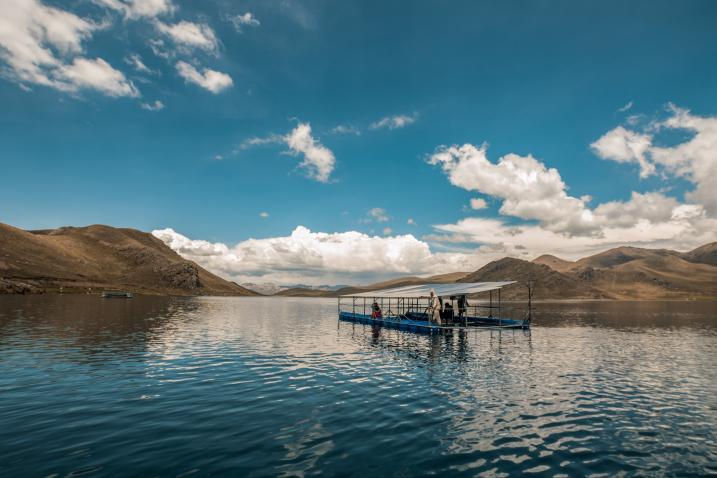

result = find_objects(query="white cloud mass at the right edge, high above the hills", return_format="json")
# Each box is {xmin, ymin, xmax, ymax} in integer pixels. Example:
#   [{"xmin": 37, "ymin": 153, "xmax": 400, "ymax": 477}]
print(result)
[{"xmin": 592, "ymin": 105, "xmax": 717, "ymax": 217}]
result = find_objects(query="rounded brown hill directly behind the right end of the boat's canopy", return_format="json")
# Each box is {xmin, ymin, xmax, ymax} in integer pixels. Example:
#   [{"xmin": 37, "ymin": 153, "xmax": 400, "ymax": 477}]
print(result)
[{"xmin": 458, "ymin": 257, "xmax": 611, "ymax": 299}]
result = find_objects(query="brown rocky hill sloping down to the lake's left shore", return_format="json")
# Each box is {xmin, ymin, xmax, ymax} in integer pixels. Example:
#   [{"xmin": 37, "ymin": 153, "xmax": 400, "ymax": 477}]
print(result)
[{"xmin": 0, "ymin": 224, "xmax": 257, "ymax": 295}]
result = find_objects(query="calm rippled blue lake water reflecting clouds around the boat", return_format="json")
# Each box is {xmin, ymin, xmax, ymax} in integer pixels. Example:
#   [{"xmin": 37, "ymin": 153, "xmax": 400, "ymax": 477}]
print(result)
[{"xmin": 0, "ymin": 296, "xmax": 717, "ymax": 476}]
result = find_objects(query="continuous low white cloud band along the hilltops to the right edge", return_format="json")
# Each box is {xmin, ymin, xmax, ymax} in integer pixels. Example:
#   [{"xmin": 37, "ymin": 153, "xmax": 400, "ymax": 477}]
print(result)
[{"xmin": 152, "ymin": 205, "xmax": 717, "ymax": 285}]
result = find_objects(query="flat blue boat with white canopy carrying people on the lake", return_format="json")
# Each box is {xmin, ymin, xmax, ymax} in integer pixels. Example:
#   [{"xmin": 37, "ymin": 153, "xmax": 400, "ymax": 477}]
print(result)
[{"xmin": 338, "ymin": 281, "xmax": 532, "ymax": 334}]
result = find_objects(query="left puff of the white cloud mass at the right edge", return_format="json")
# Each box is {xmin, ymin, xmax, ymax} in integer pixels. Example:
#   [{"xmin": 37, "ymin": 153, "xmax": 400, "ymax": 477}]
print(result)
[{"xmin": 590, "ymin": 126, "xmax": 655, "ymax": 178}]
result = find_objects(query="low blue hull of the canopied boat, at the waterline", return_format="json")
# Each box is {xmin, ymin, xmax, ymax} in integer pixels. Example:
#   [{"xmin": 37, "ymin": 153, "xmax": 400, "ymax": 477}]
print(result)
[{"xmin": 339, "ymin": 311, "xmax": 530, "ymax": 334}]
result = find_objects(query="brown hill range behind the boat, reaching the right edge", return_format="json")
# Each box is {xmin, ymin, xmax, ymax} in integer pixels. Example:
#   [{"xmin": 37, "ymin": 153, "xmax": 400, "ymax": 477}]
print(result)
[{"xmin": 278, "ymin": 242, "xmax": 717, "ymax": 300}]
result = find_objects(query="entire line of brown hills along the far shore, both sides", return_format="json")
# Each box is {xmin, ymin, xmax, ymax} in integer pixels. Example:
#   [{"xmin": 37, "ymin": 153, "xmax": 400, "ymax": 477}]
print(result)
[{"xmin": 0, "ymin": 220, "xmax": 717, "ymax": 300}]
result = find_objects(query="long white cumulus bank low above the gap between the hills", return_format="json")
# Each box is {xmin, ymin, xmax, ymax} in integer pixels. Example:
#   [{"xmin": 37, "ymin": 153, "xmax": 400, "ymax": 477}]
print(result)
[{"xmin": 152, "ymin": 226, "xmax": 462, "ymax": 283}]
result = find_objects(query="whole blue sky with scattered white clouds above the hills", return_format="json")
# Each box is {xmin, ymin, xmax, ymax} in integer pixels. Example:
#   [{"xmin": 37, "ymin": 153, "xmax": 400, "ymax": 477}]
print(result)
[{"xmin": 0, "ymin": 0, "xmax": 717, "ymax": 285}]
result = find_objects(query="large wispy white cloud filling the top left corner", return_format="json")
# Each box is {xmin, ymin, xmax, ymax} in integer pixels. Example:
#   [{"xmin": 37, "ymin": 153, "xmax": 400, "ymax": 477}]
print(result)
[{"xmin": 0, "ymin": 0, "xmax": 139, "ymax": 97}]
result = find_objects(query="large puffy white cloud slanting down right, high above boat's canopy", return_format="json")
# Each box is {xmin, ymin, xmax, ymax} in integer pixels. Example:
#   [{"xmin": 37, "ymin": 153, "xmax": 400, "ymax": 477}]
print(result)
[{"xmin": 429, "ymin": 144, "xmax": 599, "ymax": 235}]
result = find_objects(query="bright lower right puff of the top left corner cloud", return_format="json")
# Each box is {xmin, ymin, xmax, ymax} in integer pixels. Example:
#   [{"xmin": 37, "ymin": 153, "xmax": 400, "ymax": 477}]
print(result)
[{"xmin": 60, "ymin": 58, "xmax": 139, "ymax": 97}]
